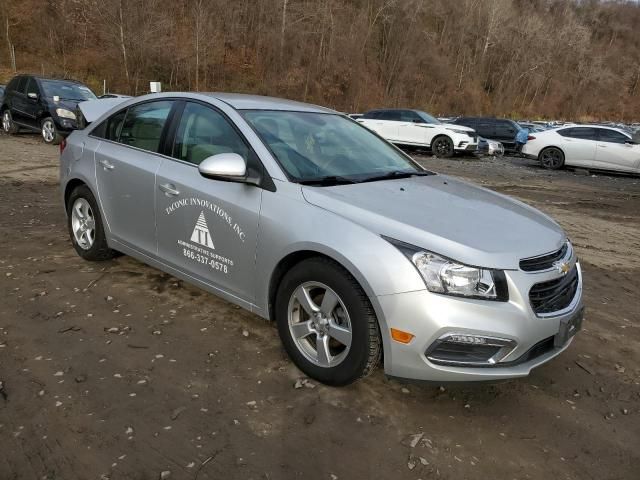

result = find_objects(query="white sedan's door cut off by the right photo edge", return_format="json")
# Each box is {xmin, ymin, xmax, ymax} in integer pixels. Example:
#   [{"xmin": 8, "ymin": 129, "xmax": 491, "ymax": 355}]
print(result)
[{"xmin": 593, "ymin": 128, "xmax": 640, "ymax": 172}]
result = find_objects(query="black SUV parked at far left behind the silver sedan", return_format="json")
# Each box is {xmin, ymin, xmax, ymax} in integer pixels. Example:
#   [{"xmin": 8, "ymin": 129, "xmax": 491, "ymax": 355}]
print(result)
[{"xmin": 0, "ymin": 75, "xmax": 96, "ymax": 144}]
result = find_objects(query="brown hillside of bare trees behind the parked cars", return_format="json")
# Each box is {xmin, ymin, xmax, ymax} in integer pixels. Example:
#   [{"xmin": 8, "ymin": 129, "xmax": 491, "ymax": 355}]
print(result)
[{"xmin": 0, "ymin": 0, "xmax": 640, "ymax": 121}]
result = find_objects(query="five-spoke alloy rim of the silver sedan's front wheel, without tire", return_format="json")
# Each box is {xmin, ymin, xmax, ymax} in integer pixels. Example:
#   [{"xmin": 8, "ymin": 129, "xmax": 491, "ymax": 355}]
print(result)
[{"xmin": 288, "ymin": 282, "xmax": 352, "ymax": 368}]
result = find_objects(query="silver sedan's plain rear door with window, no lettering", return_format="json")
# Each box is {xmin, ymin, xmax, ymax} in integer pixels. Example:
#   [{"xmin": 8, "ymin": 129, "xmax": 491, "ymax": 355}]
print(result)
[{"xmin": 95, "ymin": 100, "xmax": 174, "ymax": 255}]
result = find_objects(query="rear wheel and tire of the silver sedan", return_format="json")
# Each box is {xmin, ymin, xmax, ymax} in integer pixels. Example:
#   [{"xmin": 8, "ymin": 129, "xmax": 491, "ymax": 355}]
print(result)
[{"xmin": 67, "ymin": 185, "xmax": 116, "ymax": 261}]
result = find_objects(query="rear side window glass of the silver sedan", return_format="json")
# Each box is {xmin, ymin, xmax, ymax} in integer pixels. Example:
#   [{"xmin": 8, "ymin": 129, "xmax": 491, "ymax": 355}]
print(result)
[{"xmin": 118, "ymin": 101, "xmax": 173, "ymax": 152}]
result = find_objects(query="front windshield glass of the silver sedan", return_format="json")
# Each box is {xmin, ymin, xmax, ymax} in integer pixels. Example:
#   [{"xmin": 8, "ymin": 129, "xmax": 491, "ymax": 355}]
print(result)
[{"xmin": 243, "ymin": 110, "xmax": 425, "ymax": 181}]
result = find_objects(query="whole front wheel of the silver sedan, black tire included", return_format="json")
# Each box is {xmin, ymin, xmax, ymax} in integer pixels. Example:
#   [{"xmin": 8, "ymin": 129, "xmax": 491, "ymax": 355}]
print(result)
[{"xmin": 275, "ymin": 257, "xmax": 381, "ymax": 386}]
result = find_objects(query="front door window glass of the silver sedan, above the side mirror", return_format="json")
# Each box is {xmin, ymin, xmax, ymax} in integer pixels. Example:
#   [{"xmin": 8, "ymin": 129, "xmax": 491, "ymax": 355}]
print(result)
[{"xmin": 172, "ymin": 102, "xmax": 249, "ymax": 165}]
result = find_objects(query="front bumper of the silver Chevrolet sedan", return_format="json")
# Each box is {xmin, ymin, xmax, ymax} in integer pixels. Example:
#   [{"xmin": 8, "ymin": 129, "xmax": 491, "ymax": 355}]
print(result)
[{"xmin": 377, "ymin": 264, "xmax": 583, "ymax": 382}]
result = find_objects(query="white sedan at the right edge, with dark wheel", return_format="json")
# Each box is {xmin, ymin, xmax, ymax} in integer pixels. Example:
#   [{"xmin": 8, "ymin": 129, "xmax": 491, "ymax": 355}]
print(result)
[{"xmin": 522, "ymin": 125, "xmax": 640, "ymax": 173}]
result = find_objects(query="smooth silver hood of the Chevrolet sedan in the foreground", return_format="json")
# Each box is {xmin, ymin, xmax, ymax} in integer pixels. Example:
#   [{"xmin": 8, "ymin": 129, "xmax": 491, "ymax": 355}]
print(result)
[{"xmin": 302, "ymin": 175, "xmax": 566, "ymax": 269}]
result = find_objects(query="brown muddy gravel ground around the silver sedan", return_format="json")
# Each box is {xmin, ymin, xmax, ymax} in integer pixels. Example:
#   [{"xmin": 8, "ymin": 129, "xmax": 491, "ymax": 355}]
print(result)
[{"xmin": 0, "ymin": 135, "xmax": 640, "ymax": 480}]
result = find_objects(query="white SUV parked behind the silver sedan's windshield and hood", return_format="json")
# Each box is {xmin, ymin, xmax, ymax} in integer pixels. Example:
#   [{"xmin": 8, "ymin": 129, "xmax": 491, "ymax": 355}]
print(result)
[{"xmin": 357, "ymin": 109, "xmax": 478, "ymax": 157}]
